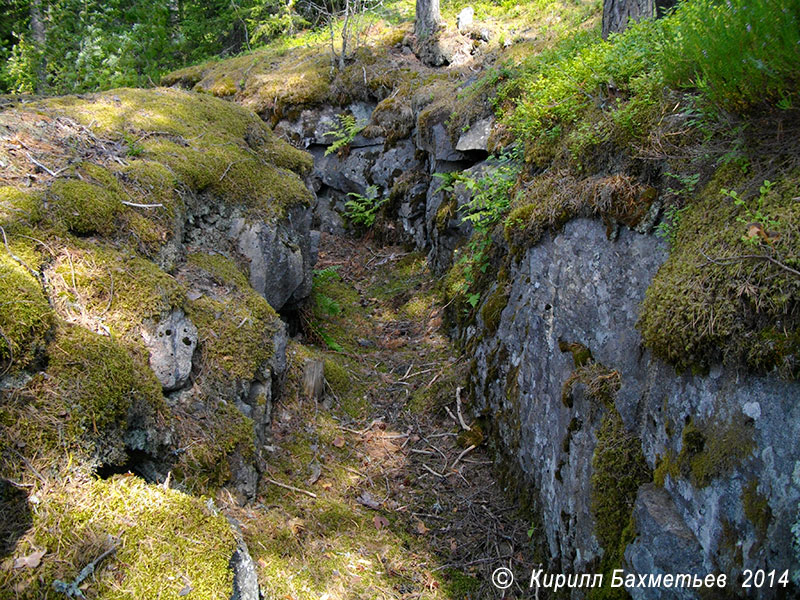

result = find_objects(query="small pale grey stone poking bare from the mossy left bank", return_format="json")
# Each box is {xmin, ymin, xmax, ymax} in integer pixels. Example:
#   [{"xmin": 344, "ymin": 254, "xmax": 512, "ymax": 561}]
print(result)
[{"xmin": 142, "ymin": 309, "xmax": 197, "ymax": 392}]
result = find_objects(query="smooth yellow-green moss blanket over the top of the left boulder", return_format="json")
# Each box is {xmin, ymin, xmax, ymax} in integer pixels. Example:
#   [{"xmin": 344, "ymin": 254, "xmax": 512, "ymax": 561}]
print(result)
[{"xmin": 41, "ymin": 89, "xmax": 312, "ymax": 219}]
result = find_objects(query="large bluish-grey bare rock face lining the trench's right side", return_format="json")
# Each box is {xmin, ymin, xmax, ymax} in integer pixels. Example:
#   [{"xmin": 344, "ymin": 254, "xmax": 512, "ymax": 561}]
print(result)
[{"xmin": 462, "ymin": 219, "xmax": 800, "ymax": 600}]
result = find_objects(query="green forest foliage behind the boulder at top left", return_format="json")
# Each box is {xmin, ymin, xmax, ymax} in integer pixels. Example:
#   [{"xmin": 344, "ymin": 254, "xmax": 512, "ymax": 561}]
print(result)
[{"xmin": 0, "ymin": 0, "xmax": 306, "ymax": 94}]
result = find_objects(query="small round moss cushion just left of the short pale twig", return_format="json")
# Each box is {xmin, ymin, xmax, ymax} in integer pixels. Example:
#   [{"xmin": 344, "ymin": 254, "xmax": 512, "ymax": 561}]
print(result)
[{"xmin": 50, "ymin": 180, "xmax": 123, "ymax": 235}]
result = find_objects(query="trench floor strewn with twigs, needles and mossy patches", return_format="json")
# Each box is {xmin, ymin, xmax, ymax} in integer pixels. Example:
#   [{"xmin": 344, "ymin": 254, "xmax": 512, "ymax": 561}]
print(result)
[{"xmin": 222, "ymin": 236, "xmax": 533, "ymax": 600}]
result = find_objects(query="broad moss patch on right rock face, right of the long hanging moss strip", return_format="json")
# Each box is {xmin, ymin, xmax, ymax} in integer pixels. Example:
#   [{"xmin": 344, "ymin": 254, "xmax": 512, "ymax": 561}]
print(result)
[{"xmin": 678, "ymin": 418, "xmax": 755, "ymax": 487}]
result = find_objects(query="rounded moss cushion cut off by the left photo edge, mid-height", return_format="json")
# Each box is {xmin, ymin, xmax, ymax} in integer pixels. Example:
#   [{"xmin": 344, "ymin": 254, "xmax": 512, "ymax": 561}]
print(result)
[{"xmin": 0, "ymin": 255, "xmax": 53, "ymax": 372}]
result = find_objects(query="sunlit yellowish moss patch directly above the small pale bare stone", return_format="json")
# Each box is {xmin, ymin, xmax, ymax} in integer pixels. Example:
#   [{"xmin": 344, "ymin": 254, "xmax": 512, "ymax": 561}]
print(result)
[{"xmin": 52, "ymin": 243, "xmax": 185, "ymax": 337}]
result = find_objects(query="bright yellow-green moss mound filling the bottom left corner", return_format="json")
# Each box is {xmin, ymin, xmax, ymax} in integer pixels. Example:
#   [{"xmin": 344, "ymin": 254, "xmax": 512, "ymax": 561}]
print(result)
[{"xmin": 0, "ymin": 476, "xmax": 236, "ymax": 600}]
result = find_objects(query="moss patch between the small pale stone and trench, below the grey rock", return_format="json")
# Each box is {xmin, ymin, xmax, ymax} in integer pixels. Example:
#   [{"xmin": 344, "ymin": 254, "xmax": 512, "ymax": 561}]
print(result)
[{"xmin": 186, "ymin": 254, "xmax": 280, "ymax": 379}]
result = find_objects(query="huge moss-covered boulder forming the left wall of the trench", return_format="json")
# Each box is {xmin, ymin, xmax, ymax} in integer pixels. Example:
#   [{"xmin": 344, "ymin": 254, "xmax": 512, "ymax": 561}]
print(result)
[{"xmin": 0, "ymin": 89, "xmax": 313, "ymax": 516}]
